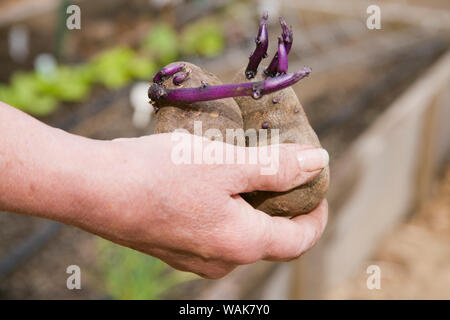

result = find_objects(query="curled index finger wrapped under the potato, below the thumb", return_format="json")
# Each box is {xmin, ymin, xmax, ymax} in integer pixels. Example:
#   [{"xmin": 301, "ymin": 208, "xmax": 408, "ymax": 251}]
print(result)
[{"xmin": 223, "ymin": 196, "xmax": 328, "ymax": 264}]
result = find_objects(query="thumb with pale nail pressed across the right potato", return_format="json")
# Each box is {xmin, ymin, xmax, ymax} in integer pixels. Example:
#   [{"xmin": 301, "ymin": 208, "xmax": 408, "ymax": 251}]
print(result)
[{"xmin": 233, "ymin": 144, "xmax": 329, "ymax": 193}]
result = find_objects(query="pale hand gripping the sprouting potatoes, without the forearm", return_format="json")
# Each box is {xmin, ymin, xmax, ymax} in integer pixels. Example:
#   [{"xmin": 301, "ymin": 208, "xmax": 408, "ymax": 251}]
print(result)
[{"xmin": 81, "ymin": 134, "xmax": 328, "ymax": 278}]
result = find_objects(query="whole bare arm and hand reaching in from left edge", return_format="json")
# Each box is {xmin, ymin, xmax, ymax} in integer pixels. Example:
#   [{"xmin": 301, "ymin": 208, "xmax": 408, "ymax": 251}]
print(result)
[{"xmin": 0, "ymin": 102, "xmax": 328, "ymax": 279}]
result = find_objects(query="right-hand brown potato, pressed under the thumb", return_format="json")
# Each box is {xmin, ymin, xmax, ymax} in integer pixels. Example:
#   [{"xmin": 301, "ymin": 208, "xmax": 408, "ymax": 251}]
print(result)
[{"xmin": 233, "ymin": 67, "xmax": 330, "ymax": 216}]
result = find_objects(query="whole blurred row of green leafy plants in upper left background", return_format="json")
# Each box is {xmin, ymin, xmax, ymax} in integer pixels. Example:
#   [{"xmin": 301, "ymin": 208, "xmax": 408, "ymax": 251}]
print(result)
[{"xmin": 0, "ymin": 19, "xmax": 224, "ymax": 116}]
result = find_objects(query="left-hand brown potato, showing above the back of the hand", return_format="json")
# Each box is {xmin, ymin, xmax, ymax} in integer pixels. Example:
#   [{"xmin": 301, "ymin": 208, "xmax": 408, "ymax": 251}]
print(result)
[{"xmin": 155, "ymin": 61, "xmax": 243, "ymax": 141}]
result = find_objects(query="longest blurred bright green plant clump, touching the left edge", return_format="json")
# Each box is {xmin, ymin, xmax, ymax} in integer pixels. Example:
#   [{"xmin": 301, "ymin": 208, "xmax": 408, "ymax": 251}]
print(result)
[{"xmin": 0, "ymin": 47, "xmax": 156, "ymax": 116}]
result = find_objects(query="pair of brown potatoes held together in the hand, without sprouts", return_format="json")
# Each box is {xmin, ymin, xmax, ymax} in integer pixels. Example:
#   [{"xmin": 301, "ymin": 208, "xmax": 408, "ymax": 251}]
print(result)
[{"xmin": 151, "ymin": 62, "xmax": 329, "ymax": 216}]
